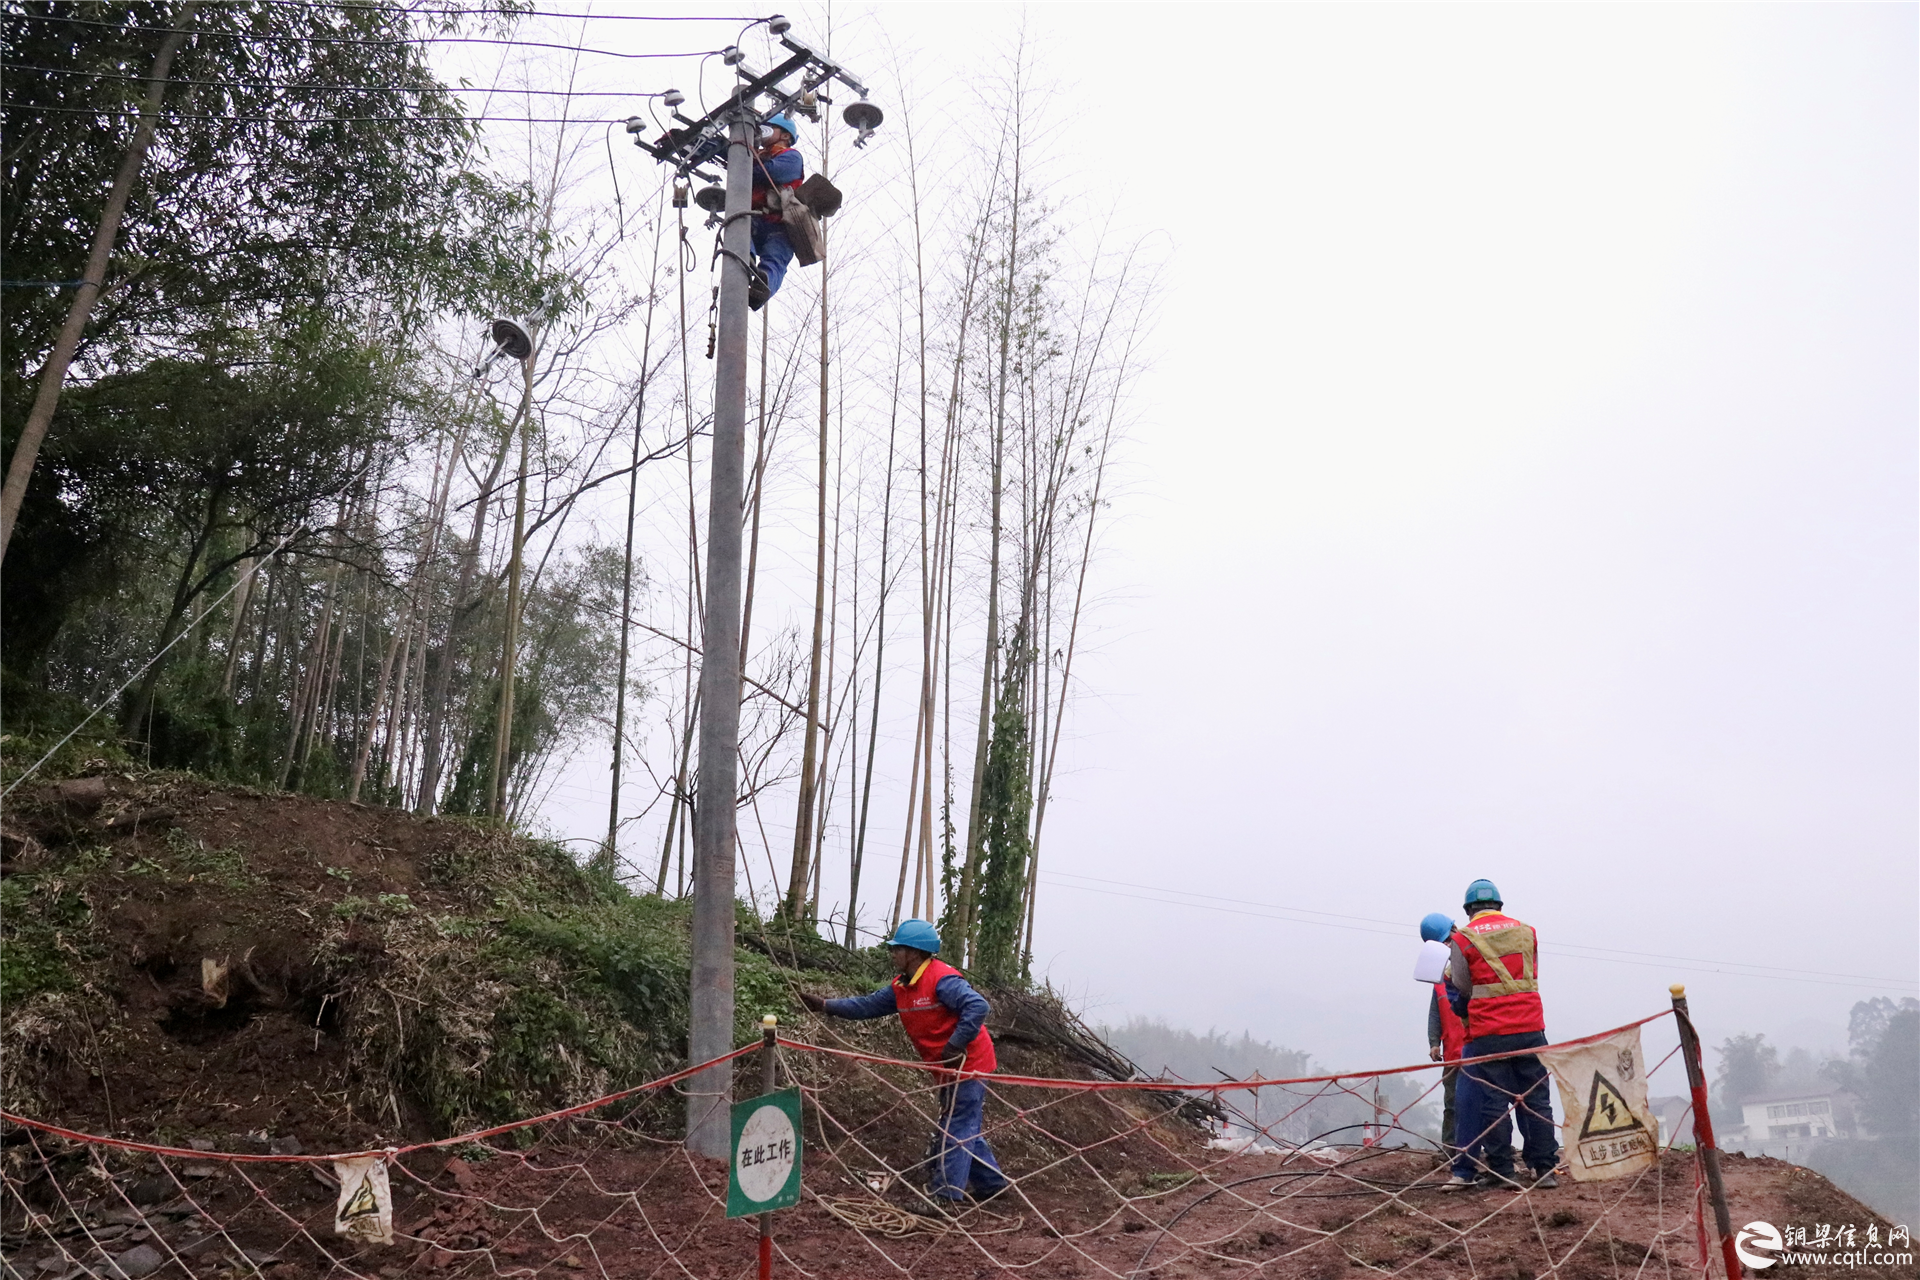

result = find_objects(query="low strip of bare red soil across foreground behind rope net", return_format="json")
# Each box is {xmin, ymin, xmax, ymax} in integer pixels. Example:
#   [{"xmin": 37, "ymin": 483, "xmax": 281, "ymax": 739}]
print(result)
[{"xmin": 0, "ymin": 1134, "xmax": 1910, "ymax": 1280}]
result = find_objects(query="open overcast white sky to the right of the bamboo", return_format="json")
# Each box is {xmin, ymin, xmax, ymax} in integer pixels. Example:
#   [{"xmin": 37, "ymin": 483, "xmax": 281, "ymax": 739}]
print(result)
[{"xmin": 503, "ymin": 4, "xmax": 1920, "ymax": 1090}]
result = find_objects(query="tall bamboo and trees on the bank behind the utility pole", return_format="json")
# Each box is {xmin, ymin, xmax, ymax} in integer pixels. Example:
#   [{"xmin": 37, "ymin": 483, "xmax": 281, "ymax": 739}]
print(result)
[{"xmin": 0, "ymin": 0, "xmax": 1154, "ymax": 981}]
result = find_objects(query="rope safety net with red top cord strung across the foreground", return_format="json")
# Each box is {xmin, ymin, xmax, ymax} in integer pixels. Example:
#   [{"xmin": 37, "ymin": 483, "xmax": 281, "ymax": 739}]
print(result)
[{"xmin": 0, "ymin": 1019, "xmax": 1709, "ymax": 1280}]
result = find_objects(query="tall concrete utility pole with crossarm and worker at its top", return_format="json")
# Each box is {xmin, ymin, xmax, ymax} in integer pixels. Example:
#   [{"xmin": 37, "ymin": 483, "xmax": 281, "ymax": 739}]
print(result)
[{"xmin": 626, "ymin": 13, "xmax": 881, "ymax": 1159}]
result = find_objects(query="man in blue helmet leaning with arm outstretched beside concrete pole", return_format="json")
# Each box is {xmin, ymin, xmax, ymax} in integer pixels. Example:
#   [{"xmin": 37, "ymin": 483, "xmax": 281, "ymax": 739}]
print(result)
[{"xmin": 801, "ymin": 919, "xmax": 1008, "ymax": 1213}]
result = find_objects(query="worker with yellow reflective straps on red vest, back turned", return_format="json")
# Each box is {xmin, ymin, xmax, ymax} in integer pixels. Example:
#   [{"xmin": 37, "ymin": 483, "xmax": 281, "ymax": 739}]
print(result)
[{"xmin": 1440, "ymin": 881, "xmax": 1559, "ymax": 1192}]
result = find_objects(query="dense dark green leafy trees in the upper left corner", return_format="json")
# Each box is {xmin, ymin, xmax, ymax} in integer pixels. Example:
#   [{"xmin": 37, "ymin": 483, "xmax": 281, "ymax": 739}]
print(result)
[{"xmin": 0, "ymin": 0, "xmax": 584, "ymax": 794}]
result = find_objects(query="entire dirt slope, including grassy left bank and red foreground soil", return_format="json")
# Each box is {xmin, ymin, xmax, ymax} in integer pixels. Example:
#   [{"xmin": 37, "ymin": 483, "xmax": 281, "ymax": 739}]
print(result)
[{"xmin": 0, "ymin": 775, "xmax": 1895, "ymax": 1280}]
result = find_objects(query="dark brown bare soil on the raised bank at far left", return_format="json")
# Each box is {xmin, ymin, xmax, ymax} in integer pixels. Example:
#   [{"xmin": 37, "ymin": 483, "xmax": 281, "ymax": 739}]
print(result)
[{"xmin": 6, "ymin": 775, "xmax": 541, "ymax": 1150}]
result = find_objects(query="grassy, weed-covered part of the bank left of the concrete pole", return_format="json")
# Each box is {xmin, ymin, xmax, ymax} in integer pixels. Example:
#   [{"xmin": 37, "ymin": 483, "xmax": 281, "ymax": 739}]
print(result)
[{"xmin": 0, "ymin": 782, "xmax": 906, "ymax": 1134}]
